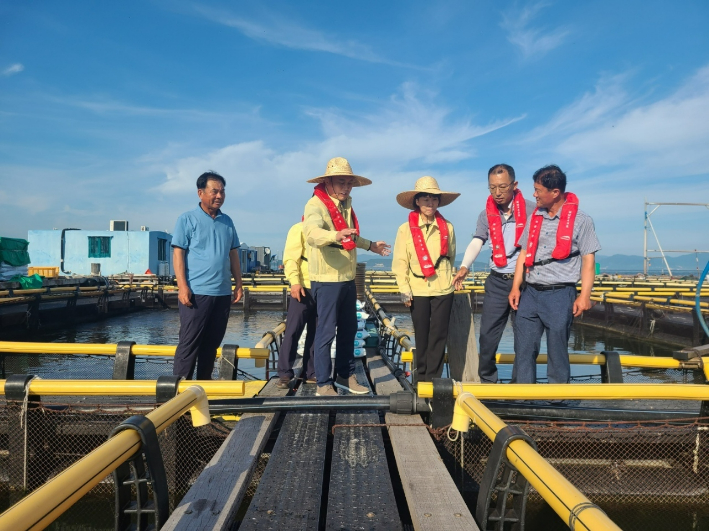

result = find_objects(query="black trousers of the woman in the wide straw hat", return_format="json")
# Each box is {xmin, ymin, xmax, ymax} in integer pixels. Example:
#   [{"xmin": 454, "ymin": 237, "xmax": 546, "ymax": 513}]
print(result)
[{"xmin": 410, "ymin": 293, "xmax": 454, "ymax": 382}]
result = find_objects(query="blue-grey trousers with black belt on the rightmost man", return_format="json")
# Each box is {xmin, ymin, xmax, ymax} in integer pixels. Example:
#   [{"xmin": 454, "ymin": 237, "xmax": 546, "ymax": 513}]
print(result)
[{"xmin": 512, "ymin": 286, "xmax": 577, "ymax": 383}]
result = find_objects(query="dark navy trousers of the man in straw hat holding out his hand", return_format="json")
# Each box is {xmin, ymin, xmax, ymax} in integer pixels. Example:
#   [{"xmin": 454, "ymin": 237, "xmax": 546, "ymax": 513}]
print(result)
[{"xmin": 311, "ymin": 280, "xmax": 357, "ymax": 386}]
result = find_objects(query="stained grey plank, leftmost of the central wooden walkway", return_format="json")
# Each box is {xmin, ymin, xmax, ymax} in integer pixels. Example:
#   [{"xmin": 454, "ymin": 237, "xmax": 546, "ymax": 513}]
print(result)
[{"xmin": 162, "ymin": 379, "xmax": 287, "ymax": 531}]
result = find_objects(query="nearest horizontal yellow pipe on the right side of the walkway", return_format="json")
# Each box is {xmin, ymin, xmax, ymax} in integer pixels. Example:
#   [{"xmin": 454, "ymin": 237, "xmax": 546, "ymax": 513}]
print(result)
[{"xmin": 417, "ymin": 382, "xmax": 708, "ymax": 400}]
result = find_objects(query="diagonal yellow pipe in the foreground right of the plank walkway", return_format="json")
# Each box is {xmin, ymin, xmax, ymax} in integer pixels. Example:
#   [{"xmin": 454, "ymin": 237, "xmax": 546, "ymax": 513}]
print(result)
[{"xmin": 458, "ymin": 394, "xmax": 619, "ymax": 531}]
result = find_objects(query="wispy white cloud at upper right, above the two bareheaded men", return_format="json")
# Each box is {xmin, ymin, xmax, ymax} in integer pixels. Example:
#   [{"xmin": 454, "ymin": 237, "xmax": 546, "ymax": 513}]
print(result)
[{"xmin": 528, "ymin": 68, "xmax": 709, "ymax": 180}]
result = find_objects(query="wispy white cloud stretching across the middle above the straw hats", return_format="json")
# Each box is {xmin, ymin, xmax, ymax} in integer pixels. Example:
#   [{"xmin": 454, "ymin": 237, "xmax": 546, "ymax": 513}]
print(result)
[{"xmin": 156, "ymin": 84, "xmax": 521, "ymax": 195}]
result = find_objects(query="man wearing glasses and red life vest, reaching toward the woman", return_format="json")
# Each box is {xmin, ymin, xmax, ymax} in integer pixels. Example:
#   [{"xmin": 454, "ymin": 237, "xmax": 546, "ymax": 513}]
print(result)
[{"xmin": 454, "ymin": 164, "xmax": 535, "ymax": 383}]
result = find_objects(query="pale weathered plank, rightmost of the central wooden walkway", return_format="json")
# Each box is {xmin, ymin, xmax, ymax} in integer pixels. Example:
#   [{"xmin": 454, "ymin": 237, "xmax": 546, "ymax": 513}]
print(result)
[{"xmin": 367, "ymin": 353, "xmax": 479, "ymax": 531}]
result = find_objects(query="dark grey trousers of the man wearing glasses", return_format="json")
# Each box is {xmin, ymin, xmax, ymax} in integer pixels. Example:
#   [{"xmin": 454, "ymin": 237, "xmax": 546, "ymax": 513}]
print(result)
[{"xmin": 478, "ymin": 275, "xmax": 515, "ymax": 383}]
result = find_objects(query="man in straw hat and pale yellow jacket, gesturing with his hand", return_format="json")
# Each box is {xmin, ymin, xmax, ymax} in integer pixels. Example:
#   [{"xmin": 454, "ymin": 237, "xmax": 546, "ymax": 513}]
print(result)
[{"xmin": 303, "ymin": 157, "xmax": 390, "ymax": 396}]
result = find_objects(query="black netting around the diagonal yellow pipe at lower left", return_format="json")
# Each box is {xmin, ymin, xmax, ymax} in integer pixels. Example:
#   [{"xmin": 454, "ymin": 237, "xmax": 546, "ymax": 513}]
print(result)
[{"xmin": 0, "ymin": 397, "xmax": 234, "ymax": 530}]
